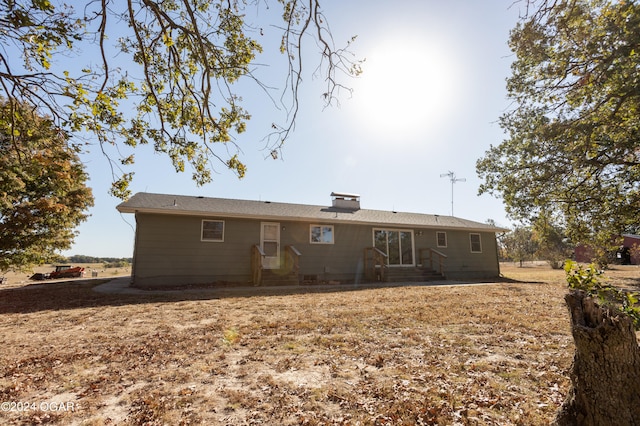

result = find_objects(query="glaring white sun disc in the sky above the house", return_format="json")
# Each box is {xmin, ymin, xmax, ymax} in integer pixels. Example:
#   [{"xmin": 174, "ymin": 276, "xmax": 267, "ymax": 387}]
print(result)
[{"xmin": 354, "ymin": 40, "xmax": 459, "ymax": 136}]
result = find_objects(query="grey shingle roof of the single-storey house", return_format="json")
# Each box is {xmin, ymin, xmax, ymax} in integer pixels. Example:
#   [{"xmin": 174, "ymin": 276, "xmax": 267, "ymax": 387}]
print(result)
[{"xmin": 117, "ymin": 192, "xmax": 507, "ymax": 232}]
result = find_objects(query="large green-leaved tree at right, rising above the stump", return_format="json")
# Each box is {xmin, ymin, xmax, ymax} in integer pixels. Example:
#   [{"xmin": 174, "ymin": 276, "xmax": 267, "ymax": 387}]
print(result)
[{"xmin": 477, "ymin": 0, "xmax": 640, "ymax": 251}]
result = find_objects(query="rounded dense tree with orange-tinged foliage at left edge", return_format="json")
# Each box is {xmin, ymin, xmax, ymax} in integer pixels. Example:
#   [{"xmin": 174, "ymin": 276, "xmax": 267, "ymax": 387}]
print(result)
[{"xmin": 0, "ymin": 102, "xmax": 93, "ymax": 271}]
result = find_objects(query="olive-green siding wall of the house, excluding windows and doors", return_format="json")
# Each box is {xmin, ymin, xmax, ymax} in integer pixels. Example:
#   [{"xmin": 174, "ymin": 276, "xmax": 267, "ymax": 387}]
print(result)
[{"xmin": 133, "ymin": 213, "xmax": 500, "ymax": 287}]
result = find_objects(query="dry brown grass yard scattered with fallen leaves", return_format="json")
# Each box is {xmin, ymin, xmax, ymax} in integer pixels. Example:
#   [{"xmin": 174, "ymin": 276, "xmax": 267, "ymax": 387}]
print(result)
[{"xmin": 0, "ymin": 265, "xmax": 640, "ymax": 425}]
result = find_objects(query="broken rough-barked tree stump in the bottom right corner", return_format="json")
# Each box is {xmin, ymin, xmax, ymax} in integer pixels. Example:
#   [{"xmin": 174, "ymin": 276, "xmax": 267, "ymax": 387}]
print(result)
[{"xmin": 554, "ymin": 290, "xmax": 640, "ymax": 426}]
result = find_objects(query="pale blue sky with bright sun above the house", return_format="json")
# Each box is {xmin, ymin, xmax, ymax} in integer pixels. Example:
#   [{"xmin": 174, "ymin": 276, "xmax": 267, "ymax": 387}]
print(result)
[{"xmin": 62, "ymin": 0, "xmax": 519, "ymax": 257}]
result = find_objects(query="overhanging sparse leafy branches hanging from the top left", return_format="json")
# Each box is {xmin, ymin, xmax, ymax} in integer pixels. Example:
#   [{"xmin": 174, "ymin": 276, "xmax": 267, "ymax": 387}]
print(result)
[{"xmin": 0, "ymin": 0, "xmax": 361, "ymax": 198}]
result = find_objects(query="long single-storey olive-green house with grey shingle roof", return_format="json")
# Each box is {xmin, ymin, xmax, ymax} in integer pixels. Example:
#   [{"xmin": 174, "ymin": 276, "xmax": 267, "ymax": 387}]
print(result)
[{"xmin": 117, "ymin": 192, "xmax": 506, "ymax": 287}]
